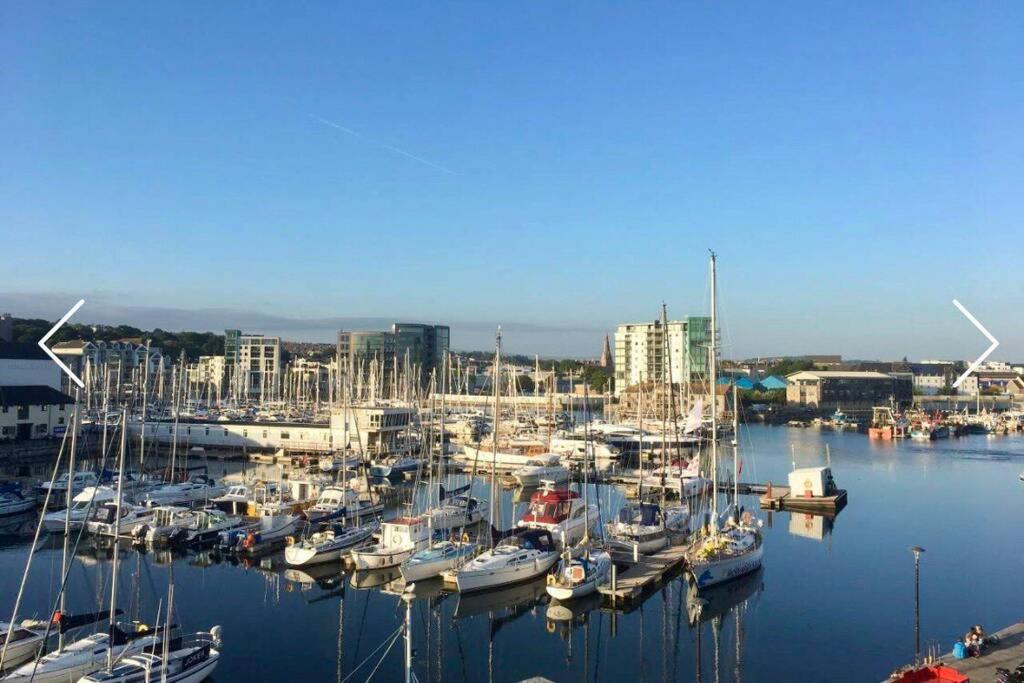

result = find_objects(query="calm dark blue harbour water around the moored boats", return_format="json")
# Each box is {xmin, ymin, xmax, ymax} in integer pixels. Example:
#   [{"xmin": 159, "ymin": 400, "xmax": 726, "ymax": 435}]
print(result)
[{"xmin": 0, "ymin": 426, "xmax": 1024, "ymax": 681}]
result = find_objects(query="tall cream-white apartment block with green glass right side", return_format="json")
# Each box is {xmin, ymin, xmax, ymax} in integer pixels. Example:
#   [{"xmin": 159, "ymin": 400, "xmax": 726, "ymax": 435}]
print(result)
[{"xmin": 614, "ymin": 315, "xmax": 711, "ymax": 396}]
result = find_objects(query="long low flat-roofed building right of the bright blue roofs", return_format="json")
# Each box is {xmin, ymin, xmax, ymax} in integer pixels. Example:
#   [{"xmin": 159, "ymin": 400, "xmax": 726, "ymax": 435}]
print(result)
[{"xmin": 785, "ymin": 370, "xmax": 913, "ymax": 411}]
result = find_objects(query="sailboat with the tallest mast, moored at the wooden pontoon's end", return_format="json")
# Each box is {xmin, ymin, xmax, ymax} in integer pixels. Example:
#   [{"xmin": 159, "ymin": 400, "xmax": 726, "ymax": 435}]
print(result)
[{"xmin": 686, "ymin": 253, "xmax": 764, "ymax": 589}]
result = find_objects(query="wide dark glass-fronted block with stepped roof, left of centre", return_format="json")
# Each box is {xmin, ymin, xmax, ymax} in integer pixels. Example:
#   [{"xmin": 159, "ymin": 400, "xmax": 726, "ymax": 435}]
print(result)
[{"xmin": 337, "ymin": 323, "xmax": 451, "ymax": 384}]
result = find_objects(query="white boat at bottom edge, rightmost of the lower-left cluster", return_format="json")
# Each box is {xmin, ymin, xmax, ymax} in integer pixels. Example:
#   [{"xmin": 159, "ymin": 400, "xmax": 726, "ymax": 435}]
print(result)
[{"xmin": 79, "ymin": 626, "xmax": 221, "ymax": 683}]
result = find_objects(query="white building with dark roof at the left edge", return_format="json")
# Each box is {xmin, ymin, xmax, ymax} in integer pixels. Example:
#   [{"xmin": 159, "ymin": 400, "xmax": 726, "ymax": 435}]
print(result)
[{"xmin": 0, "ymin": 341, "xmax": 75, "ymax": 441}]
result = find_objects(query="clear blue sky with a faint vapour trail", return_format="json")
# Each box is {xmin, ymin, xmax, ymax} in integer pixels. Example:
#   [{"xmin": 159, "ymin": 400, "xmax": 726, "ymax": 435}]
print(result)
[{"xmin": 0, "ymin": 2, "xmax": 1024, "ymax": 358}]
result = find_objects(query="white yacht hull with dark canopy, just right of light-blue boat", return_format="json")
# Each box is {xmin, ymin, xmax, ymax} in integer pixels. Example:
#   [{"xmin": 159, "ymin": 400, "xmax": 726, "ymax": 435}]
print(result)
[{"xmin": 454, "ymin": 528, "xmax": 559, "ymax": 593}]
